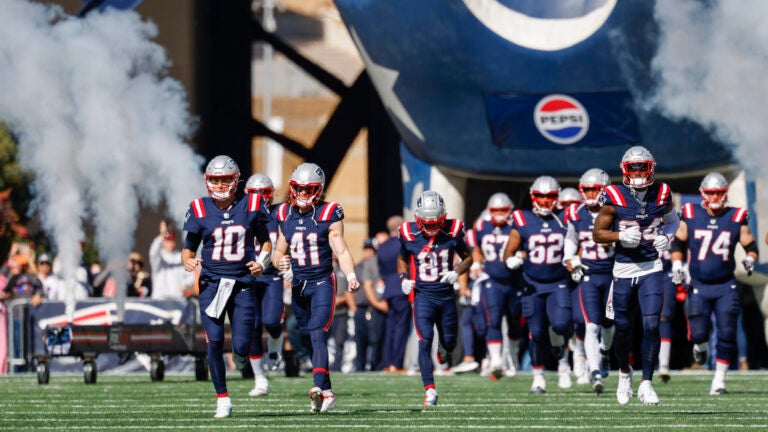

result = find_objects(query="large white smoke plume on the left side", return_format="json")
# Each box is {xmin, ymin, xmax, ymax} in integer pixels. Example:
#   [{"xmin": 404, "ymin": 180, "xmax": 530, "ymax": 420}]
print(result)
[{"xmin": 0, "ymin": 0, "xmax": 204, "ymax": 318}]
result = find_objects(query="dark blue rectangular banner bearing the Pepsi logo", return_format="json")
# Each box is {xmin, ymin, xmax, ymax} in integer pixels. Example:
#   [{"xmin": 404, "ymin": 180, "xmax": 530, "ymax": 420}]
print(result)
[{"xmin": 485, "ymin": 90, "xmax": 640, "ymax": 149}]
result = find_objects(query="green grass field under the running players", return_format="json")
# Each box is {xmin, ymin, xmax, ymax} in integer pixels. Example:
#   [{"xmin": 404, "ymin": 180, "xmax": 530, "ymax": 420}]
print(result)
[{"xmin": 0, "ymin": 371, "xmax": 768, "ymax": 431}]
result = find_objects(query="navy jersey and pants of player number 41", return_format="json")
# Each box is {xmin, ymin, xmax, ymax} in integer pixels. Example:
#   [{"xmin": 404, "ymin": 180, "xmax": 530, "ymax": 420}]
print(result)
[{"xmin": 275, "ymin": 201, "xmax": 344, "ymax": 390}]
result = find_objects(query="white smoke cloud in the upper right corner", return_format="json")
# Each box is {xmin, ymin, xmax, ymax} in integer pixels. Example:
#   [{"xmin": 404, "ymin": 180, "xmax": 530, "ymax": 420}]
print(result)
[{"xmin": 652, "ymin": 0, "xmax": 768, "ymax": 261}]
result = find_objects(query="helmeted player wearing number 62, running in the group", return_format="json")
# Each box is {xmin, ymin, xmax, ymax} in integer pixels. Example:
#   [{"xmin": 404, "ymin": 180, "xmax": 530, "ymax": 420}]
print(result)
[{"xmin": 504, "ymin": 176, "xmax": 573, "ymax": 394}]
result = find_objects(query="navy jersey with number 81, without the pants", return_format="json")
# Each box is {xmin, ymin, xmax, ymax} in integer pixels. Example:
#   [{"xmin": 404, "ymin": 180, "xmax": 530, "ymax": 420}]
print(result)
[{"xmin": 400, "ymin": 219, "xmax": 468, "ymax": 300}]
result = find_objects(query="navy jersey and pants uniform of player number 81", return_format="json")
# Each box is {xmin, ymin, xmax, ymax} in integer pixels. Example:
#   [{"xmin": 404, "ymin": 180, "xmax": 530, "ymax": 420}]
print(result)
[{"xmin": 400, "ymin": 219, "xmax": 469, "ymax": 390}]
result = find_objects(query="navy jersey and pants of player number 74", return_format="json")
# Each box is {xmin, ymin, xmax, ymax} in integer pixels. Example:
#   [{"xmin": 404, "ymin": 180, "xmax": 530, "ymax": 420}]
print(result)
[{"xmin": 682, "ymin": 203, "xmax": 749, "ymax": 364}]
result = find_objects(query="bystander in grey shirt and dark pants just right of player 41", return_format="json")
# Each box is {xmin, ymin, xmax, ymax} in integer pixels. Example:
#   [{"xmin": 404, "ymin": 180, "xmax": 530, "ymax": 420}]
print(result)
[{"xmin": 355, "ymin": 233, "xmax": 389, "ymax": 372}]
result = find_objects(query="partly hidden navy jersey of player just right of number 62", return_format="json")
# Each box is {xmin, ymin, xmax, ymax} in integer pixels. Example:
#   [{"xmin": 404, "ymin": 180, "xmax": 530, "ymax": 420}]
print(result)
[{"xmin": 568, "ymin": 204, "xmax": 613, "ymax": 273}]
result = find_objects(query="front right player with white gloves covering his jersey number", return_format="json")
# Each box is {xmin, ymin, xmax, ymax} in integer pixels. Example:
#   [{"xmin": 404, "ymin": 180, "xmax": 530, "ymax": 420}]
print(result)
[{"xmin": 592, "ymin": 146, "xmax": 680, "ymax": 405}]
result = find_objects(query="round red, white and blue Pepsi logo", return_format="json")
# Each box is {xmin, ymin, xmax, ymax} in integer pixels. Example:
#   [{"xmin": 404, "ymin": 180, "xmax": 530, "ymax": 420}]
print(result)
[{"xmin": 533, "ymin": 94, "xmax": 589, "ymax": 144}]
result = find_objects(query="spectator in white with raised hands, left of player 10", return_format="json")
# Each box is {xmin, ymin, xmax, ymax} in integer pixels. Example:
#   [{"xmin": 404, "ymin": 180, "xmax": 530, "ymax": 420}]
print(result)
[{"xmin": 149, "ymin": 220, "xmax": 194, "ymax": 300}]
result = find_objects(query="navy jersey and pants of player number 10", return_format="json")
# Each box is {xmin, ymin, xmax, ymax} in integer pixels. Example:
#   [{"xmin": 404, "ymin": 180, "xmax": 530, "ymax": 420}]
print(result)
[{"xmin": 184, "ymin": 194, "xmax": 270, "ymax": 397}]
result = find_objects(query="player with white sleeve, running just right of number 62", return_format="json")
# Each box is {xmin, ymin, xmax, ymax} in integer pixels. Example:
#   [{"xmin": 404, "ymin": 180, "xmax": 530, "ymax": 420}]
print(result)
[{"xmin": 563, "ymin": 168, "xmax": 613, "ymax": 394}]
